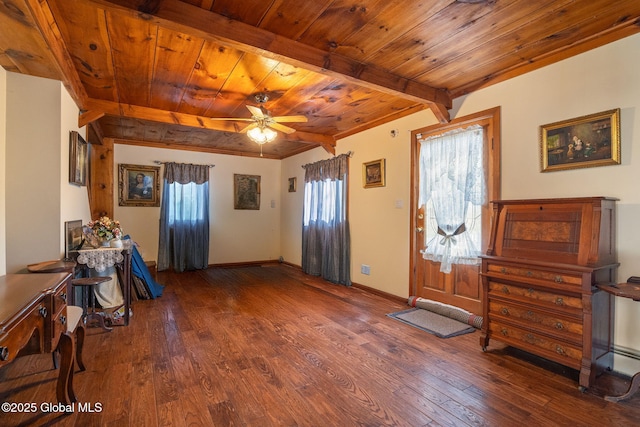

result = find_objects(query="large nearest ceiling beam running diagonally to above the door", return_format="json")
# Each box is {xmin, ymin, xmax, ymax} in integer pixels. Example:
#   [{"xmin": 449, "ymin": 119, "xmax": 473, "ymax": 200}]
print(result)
[{"xmin": 90, "ymin": 0, "xmax": 452, "ymax": 122}]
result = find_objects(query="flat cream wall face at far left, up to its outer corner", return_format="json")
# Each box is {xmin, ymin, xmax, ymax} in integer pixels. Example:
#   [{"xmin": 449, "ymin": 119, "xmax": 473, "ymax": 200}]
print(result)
[{"xmin": 6, "ymin": 73, "xmax": 61, "ymax": 273}]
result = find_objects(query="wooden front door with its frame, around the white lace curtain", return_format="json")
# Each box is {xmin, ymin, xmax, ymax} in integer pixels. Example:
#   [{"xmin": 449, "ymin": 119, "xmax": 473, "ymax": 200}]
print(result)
[{"xmin": 409, "ymin": 108, "xmax": 500, "ymax": 314}]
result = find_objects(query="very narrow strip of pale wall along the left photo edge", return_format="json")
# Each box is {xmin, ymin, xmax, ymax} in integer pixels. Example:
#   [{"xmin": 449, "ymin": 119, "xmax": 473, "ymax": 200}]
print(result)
[{"xmin": 0, "ymin": 67, "xmax": 7, "ymax": 276}]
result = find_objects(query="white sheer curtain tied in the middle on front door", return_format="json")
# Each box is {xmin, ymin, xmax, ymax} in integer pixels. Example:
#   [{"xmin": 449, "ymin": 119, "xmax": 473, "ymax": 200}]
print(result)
[{"xmin": 418, "ymin": 125, "xmax": 486, "ymax": 273}]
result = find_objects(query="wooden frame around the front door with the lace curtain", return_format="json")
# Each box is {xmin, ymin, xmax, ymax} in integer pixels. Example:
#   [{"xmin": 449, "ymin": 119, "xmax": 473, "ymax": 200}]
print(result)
[{"xmin": 409, "ymin": 107, "xmax": 501, "ymax": 295}]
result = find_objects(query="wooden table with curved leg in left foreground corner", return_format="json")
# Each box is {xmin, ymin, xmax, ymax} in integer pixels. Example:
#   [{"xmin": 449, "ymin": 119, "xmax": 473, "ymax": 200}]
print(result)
[{"xmin": 0, "ymin": 273, "xmax": 76, "ymax": 405}]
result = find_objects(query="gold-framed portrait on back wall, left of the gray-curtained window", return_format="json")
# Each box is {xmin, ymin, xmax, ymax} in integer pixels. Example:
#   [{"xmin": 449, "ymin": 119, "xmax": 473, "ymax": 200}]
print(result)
[{"xmin": 118, "ymin": 164, "xmax": 160, "ymax": 207}]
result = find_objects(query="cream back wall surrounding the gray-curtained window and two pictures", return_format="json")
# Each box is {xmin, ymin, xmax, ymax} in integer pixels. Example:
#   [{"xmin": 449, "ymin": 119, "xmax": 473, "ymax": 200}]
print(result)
[{"xmin": 114, "ymin": 144, "xmax": 282, "ymax": 264}]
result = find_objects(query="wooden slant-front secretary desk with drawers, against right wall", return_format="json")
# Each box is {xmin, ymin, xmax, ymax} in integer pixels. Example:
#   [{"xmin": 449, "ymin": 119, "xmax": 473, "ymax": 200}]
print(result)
[{"xmin": 480, "ymin": 197, "xmax": 618, "ymax": 390}]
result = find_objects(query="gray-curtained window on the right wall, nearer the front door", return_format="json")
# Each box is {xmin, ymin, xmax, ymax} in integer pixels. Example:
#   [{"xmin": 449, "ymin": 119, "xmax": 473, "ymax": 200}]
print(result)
[{"xmin": 302, "ymin": 154, "xmax": 351, "ymax": 286}]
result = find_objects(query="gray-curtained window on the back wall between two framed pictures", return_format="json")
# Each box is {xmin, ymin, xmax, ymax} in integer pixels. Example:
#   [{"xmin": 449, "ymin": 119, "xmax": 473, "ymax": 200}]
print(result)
[{"xmin": 158, "ymin": 163, "xmax": 209, "ymax": 272}]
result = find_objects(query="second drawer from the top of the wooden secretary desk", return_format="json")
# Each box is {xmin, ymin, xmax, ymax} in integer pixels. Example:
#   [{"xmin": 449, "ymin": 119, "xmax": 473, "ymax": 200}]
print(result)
[{"xmin": 489, "ymin": 282, "xmax": 582, "ymax": 314}]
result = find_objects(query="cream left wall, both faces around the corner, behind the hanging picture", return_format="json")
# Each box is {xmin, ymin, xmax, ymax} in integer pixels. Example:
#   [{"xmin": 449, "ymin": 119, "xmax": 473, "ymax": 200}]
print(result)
[{"xmin": 2, "ymin": 70, "xmax": 90, "ymax": 273}]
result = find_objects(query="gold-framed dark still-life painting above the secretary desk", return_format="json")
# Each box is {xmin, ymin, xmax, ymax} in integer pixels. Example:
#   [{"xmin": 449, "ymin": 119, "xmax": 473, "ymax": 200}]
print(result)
[{"xmin": 540, "ymin": 108, "xmax": 620, "ymax": 172}]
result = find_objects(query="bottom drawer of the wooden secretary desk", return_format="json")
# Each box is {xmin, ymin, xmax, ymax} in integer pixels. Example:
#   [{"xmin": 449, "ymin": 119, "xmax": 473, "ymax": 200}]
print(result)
[{"xmin": 489, "ymin": 322, "xmax": 582, "ymax": 369}]
